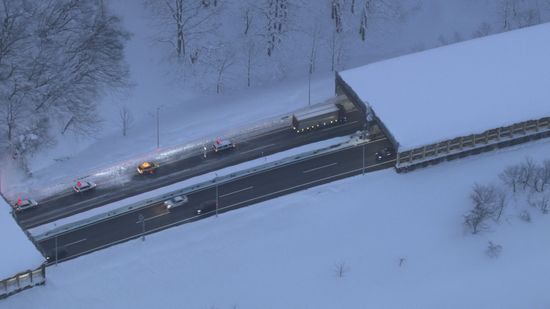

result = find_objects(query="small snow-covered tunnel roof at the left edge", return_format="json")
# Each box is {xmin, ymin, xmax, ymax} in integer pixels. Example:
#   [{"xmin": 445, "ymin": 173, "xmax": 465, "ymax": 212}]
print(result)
[{"xmin": 0, "ymin": 196, "xmax": 44, "ymax": 280}]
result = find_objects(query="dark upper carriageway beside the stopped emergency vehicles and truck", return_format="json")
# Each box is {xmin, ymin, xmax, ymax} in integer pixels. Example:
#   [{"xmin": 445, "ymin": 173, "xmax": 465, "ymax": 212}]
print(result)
[{"xmin": 16, "ymin": 111, "xmax": 364, "ymax": 229}]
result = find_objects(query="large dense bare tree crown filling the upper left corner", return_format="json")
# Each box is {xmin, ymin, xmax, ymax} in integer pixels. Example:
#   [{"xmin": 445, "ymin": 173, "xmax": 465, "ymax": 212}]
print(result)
[{"xmin": 0, "ymin": 0, "xmax": 128, "ymax": 168}]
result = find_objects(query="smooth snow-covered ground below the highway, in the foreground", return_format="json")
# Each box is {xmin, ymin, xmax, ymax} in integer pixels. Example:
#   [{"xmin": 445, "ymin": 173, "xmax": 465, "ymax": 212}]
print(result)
[{"xmin": 4, "ymin": 128, "xmax": 550, "ymax": 309}]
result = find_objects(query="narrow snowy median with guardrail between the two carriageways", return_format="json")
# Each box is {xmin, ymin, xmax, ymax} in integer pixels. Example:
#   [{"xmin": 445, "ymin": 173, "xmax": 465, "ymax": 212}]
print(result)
[{"xmin": 33, "ymin": 133, "xmax": 368, "ymax": 241}]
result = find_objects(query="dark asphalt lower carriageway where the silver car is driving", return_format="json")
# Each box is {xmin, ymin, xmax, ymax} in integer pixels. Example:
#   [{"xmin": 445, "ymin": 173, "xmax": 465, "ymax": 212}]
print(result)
[{"xmin": 38, "ymin": 138, "xmax": 395, "ymax": 263}]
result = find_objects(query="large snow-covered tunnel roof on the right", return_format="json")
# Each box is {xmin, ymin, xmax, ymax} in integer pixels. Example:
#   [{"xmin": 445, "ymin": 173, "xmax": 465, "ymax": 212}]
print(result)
[{"xmin": 340, "ymin": 24, "xmax": 550, "ymax": 151}]
